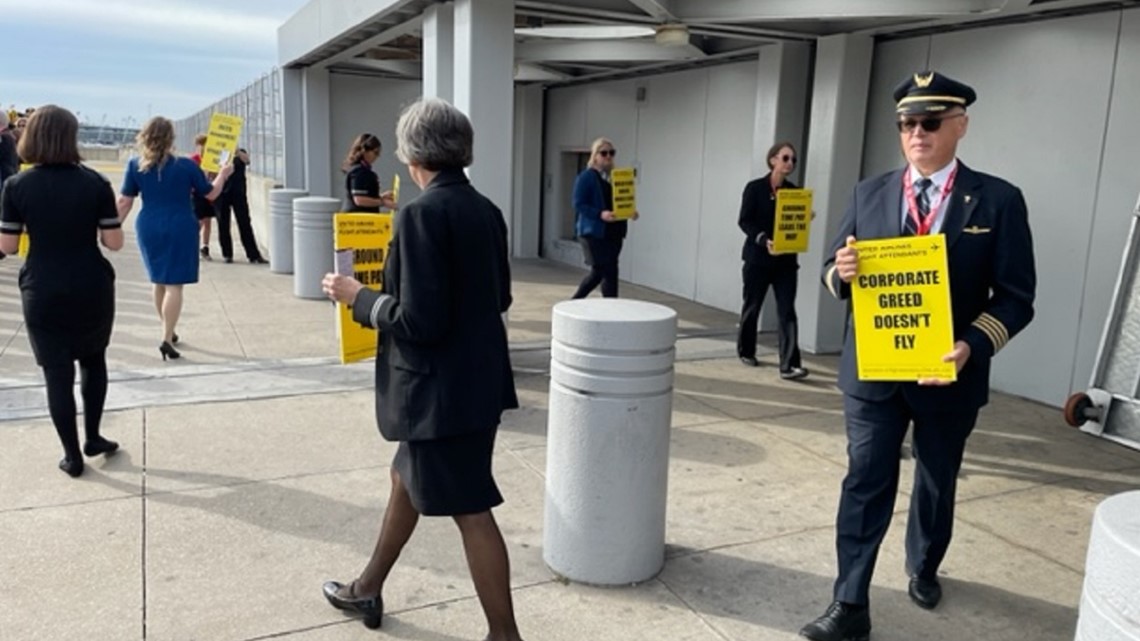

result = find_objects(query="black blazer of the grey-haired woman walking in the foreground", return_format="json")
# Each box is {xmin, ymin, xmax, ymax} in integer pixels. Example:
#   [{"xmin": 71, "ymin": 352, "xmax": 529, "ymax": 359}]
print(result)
[{"xmin": 352, "ymin": 170, "xmax": 519, "ymax": 440}]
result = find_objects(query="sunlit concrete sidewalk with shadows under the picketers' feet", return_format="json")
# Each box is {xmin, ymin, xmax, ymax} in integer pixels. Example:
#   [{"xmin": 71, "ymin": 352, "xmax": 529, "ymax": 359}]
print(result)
[{"xmin": 0, "ymin": 172, "xmax": 1140, "ymax": 641}]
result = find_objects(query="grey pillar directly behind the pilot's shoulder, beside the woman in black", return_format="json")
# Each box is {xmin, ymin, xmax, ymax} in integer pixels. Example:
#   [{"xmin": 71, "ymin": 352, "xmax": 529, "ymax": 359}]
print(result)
[{"xmin": 796, "ymin": 34, "xmax": 870, "ymax": 354}]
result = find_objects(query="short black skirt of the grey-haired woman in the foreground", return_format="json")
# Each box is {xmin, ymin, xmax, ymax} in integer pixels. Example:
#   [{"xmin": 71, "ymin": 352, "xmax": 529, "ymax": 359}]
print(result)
[{"xmin": 392, "ymin": 428, "xmax": 503, "ymax": 517}]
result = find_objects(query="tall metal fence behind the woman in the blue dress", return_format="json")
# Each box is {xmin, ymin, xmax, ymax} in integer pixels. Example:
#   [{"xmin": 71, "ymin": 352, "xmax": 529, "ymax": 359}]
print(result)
[{"xmin": 174, "ymin": 68, "xmax": 285, "ymax": 182}]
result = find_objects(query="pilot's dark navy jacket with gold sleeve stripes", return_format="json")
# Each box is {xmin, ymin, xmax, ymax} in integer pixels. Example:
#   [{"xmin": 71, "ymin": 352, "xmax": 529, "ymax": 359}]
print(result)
[{"xmin": 823, "ymin": 162, "xmax": 1037, "ymax": 409}]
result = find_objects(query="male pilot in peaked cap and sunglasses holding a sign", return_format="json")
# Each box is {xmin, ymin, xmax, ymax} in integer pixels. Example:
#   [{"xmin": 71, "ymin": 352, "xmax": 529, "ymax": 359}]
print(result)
[{"xmin": 800, "ymin": 72, "xmax": 1036, "ymax": 641}]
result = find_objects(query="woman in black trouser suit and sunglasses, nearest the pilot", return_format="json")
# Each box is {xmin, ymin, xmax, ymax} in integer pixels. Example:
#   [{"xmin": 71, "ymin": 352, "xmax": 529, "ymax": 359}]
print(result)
[{"xmin": 736, "ymin": 143, "xmax": 807, "ymax": 380}]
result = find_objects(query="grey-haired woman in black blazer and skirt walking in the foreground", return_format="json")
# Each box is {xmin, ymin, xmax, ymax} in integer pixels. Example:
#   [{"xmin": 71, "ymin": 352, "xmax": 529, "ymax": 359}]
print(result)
[{"xmin": 323, "ymin": 98, "xmax": 520, "ymax": 641}]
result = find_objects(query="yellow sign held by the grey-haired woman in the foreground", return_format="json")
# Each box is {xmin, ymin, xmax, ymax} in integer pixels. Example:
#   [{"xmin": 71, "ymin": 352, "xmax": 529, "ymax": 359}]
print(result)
[{"xmin": 333, "ymin": 213, "xmax": 392, "ymax": 364}]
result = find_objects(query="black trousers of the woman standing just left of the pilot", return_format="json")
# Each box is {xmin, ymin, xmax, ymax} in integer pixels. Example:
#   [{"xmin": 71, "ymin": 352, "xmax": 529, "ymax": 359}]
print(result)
[{"xmin": 736, "ymin": 260, "xmax": 800, "ymax": 372}]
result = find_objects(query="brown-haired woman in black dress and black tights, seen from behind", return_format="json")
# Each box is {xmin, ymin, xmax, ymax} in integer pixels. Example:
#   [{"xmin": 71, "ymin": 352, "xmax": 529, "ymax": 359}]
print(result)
[{"xmin": 0, "ymin": 105, "xmax": 123, "ymax": 477}]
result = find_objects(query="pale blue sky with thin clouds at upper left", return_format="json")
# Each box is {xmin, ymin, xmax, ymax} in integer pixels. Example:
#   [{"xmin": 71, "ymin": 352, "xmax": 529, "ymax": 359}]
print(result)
[{"xmin": 0, "ymin": 0, "xmax": 308, "ymax": 127}]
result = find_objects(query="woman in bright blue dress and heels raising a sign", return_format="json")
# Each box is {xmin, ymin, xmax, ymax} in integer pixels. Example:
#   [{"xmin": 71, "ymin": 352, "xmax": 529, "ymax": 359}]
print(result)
[{"xmin": 119, "ymin": 116, "xmax": 234, "ymax": 360}]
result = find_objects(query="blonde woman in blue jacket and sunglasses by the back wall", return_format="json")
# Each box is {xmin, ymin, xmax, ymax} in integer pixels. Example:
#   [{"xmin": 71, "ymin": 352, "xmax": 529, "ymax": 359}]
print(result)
[{"xmin": 572, "ymin": 138, "xmax": 638, "ymax": 299}]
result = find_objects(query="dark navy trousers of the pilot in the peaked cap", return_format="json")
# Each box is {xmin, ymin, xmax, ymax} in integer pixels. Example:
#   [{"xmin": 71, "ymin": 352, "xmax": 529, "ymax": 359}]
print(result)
[{"xmin": 834, "ymin": 383, "xmax": 978, "ymax": 605}]
